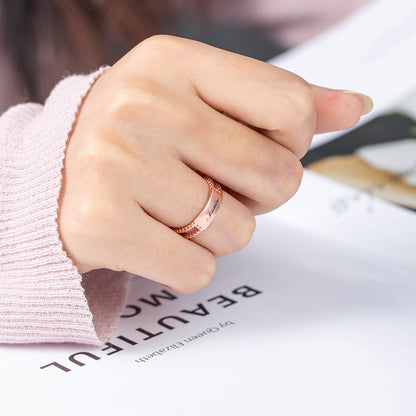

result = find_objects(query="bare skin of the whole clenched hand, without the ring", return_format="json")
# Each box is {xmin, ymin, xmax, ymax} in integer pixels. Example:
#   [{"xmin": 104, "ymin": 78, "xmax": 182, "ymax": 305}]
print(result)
[{"xmin": 58, "ymin": 35, "xmax": 371, "ymax": 293}]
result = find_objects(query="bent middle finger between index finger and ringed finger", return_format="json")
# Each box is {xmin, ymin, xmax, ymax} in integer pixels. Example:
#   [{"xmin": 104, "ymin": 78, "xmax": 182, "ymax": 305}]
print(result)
[{"xmin": 175, "ymin": 98, "xmax": 303, "ymax": 214}]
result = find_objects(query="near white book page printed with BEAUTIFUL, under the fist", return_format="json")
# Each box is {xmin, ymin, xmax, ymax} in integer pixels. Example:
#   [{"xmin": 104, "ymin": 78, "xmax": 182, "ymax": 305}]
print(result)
[{"xmin": 0, "ymin": 213, "xmax": 416, "ymax": 416}]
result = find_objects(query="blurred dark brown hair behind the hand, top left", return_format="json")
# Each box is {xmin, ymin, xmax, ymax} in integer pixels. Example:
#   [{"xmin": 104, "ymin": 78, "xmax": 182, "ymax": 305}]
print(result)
[{"xmin": 0, "ymin": 0, "xmax": 172, "ymax": 101}]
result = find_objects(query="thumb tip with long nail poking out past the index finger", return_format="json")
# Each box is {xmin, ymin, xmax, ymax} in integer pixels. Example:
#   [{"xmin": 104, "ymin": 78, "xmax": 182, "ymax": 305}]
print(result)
[{"xmin": 312, "ymin": 85, "xmax": 373, "ymax": 133}]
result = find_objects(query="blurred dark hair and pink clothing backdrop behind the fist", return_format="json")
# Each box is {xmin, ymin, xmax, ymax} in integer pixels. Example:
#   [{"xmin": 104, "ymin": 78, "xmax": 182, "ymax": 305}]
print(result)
[{"xmin": 0, "ymin": 0, "xmax": 368, "ymax": 113}]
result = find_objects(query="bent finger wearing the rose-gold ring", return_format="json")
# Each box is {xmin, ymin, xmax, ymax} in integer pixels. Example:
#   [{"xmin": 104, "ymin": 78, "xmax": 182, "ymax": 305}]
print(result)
[{"xmin": 131, "ymin": 159, "xmax": 255, "ymax": 257}]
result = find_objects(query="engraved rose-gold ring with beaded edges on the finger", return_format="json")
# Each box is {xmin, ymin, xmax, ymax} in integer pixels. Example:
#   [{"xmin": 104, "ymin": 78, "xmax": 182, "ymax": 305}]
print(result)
[{"xmin": 172, "ymin": 175, "xmax": 222, "ymax": 240}]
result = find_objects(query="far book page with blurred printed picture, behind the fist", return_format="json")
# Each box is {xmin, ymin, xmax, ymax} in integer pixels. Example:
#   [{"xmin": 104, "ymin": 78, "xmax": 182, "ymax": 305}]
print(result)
[{"xmin": 271, "ymin": 0, "xmax": 416, "ymax": 271}]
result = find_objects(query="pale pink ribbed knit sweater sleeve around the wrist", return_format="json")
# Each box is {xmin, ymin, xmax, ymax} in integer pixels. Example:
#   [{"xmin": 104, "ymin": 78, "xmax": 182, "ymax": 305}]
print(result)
[{"xmin": 0, "ymin": 69, "xmax": 128, "ymax": 345}]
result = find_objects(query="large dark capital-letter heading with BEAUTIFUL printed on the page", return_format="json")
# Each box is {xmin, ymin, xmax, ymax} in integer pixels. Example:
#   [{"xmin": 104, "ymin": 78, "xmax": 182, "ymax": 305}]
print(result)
[{"xmin": 40, "ymin": 285, "xmax": 261, "ymax": 373}]
